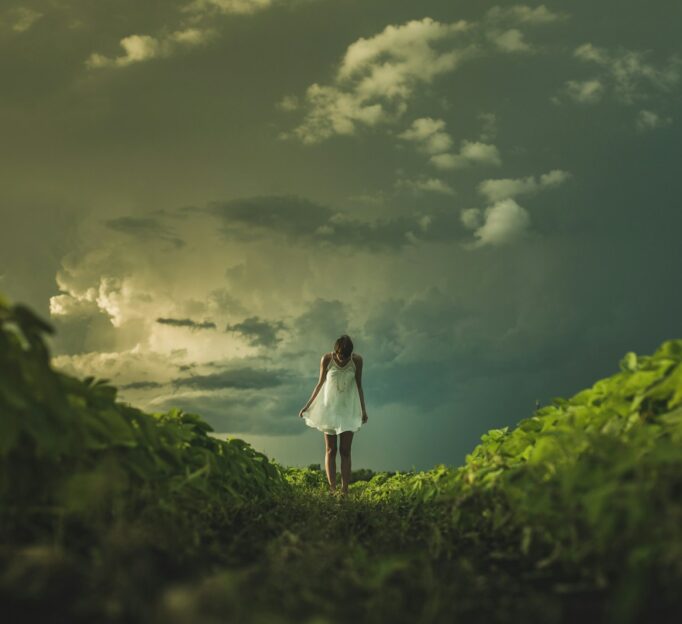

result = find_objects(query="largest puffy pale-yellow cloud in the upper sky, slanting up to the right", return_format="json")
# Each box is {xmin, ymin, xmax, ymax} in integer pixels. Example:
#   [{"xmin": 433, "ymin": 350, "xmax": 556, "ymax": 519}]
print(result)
[{"xmin": 285, "ymin": 17, "xmax": 479, "ymax": 144}]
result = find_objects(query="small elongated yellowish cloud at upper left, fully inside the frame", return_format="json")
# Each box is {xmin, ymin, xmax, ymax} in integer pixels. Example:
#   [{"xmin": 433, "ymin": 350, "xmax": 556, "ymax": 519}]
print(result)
[{"xmin": 85, "ymin": 28, "xmax": 215, "ymax": 69}]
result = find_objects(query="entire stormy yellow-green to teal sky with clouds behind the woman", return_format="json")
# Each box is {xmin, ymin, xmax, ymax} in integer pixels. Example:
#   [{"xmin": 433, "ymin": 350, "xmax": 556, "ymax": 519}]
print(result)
[{"xmin": 0, "ymin": 0, "xmax": 682, "ymax": 470}]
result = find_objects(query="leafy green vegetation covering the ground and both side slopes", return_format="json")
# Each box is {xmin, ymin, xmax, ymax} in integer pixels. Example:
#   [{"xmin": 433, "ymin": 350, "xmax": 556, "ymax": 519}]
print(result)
[{"xmin": 0, "ymin": 300, "xmax": 682, "ymax": 624}]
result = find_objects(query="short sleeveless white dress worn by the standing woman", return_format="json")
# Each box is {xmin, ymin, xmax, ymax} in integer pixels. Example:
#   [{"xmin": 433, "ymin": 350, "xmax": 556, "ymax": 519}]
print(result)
[{"xmin": 303, "ymin": 355, "xmax": 362, "ymax": 434}]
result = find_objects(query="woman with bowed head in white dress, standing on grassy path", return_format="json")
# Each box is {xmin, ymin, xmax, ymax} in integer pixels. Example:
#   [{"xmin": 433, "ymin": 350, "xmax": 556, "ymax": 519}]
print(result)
[{"xmin": 298, "ymin": 334, "xmax": 367, "ymax": 496}]
